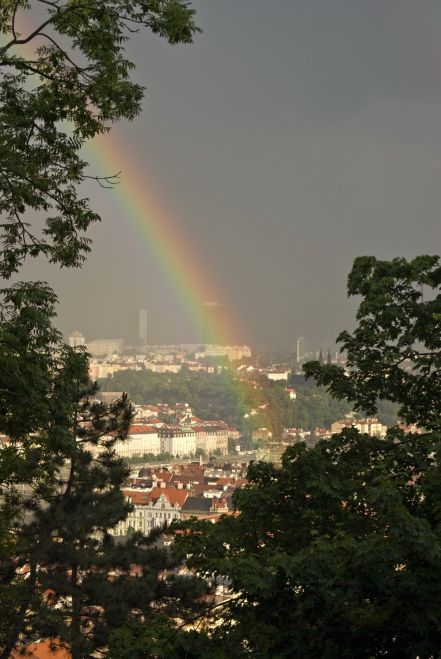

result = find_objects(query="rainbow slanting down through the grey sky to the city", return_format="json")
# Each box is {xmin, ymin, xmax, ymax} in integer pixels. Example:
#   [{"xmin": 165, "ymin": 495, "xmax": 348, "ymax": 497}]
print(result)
[{"xmin": 0, "ymin": 21, "xmax": 243, "ymax": 345}]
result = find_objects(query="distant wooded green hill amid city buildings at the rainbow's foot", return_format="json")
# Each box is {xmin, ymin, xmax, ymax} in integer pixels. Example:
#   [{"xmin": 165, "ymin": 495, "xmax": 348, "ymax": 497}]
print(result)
[{"xmin": 100, "ymin": 371, "xmax": 352, "ymax": 437}]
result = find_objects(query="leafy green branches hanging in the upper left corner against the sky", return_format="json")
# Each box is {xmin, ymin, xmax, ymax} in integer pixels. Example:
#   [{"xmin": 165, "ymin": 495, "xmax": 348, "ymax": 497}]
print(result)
[{"xmin": 0, "ymin": 0, "xmax": 198, "ymax": 277}]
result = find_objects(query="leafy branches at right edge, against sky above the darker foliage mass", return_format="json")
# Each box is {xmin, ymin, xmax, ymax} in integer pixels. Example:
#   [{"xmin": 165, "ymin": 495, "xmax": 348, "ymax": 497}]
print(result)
[{"xmin": 305, "ymin": 256, "xmax": 441, "ymax": 430}]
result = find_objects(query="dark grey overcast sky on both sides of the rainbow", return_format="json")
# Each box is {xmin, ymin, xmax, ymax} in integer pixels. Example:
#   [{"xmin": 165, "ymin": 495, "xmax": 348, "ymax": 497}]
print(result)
[{"xmin": 21, "ymin": 0, "xmax": 441, "ymax": 347}]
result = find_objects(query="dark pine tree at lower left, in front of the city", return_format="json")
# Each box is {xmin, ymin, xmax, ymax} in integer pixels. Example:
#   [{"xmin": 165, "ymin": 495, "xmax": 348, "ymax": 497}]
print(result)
[{"xmin": 0, "ymin": 291, "xmax": 207, "ymax": 659}]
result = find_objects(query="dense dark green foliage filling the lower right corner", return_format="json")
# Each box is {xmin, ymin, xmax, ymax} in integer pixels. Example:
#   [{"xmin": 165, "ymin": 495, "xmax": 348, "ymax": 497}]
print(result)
[{"xmin": 179, "ymin": 430, "xmax": 441, "ymax": 659}]
